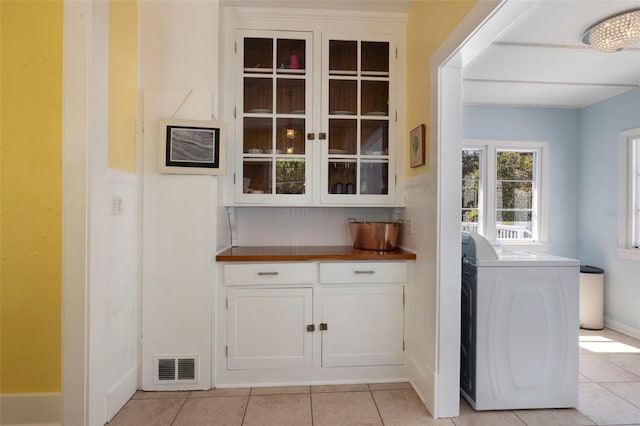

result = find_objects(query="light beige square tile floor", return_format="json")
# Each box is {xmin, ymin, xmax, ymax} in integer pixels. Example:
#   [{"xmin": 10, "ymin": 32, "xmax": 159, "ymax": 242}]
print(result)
[{"xmin": 108, "ymin": 329, "xmax": 640, "ymax": 426}]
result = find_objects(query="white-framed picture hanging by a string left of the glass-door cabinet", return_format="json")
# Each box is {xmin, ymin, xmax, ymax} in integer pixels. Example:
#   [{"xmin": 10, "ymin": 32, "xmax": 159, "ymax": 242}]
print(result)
[{"xmin": 160, "ymin": 120, "xmax": 226, "ymax": 175}]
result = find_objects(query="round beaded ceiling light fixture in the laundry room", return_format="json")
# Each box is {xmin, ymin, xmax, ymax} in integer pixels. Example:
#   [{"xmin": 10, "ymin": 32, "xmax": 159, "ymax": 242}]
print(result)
[{"xmin": 582, "ymin": 9, "xmax": 640, "ymax": 52}]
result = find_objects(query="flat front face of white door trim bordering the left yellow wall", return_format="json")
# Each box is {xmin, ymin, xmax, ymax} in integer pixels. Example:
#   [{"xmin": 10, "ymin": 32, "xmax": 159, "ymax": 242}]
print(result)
[{"xmin": 62, "ymin": 1, "xmax": 91, "ymax": 425}]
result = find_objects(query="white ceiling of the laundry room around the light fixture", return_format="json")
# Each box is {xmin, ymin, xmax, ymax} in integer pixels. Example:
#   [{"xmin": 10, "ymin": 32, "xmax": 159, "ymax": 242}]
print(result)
[{"xmin": 463, "ymin": 0, "xmax": 640, "ymax": 108}]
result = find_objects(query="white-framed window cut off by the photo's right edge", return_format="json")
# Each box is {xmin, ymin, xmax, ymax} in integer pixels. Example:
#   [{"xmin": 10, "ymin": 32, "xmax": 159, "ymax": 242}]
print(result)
[{"xmin": 618, "ymin": 128, "xmax": 640, "ymax": 258}]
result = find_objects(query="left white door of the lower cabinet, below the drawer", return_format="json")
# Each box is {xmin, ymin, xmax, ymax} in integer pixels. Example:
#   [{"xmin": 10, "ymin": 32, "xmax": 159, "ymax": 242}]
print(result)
[{"xmin": 227, "ymin": 288, "xmax": 313, "ymax": 370}]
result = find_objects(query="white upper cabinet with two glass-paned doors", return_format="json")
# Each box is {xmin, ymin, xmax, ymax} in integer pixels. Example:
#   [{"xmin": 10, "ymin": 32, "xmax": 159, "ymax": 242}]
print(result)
[{"xmin": 225, "ymin": 11, "xmax": 404, "ymax": 206}]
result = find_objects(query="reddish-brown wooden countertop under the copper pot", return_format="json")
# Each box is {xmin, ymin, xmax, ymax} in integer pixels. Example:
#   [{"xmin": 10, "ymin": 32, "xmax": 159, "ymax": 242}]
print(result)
[{"xmin": 216, "ymin": 246, "xmax": 416, "ymax": 262}]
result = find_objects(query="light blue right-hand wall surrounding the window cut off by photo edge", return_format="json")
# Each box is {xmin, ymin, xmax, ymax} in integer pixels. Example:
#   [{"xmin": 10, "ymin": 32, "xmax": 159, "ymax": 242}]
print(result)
[{"xmin": 576, "ymin": 89, "xmax": 640, "ymax": 337}]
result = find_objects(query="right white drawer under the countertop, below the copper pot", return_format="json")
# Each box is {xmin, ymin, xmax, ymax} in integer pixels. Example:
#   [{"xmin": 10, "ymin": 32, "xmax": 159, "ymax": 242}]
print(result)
[{"xmin": 320, "ymin": 262, "xmax": 407, "ymax": 284}]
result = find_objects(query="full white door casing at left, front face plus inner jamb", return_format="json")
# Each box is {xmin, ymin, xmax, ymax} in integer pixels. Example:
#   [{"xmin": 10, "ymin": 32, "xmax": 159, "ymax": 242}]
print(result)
[{"xmin": 62, "ymin": 0, "xmax": 109, "ymax": 425}]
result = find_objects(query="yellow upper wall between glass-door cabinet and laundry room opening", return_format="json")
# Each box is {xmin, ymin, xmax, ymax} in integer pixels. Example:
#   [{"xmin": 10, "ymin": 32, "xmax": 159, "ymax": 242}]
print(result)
[{"xmin": 405, "ymin": 0, "xmax": 477, "ymax": 177}]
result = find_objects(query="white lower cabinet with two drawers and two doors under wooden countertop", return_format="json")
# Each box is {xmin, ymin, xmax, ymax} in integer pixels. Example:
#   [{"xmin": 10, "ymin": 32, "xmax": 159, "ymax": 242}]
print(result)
[{"xmin": 216, "ymin": 261, "xmax": 409, "ymax": 385}]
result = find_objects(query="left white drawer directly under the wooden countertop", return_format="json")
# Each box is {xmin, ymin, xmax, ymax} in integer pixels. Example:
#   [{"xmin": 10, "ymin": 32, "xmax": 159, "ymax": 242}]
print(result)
[{"xmin": 224, "ymin": 262, "xmax": 316, "ymax": 286}]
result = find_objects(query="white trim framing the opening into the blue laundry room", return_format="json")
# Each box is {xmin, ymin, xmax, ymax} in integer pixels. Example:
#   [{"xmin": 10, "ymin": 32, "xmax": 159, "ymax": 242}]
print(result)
[{"xmin": 429, "ymin": 0, "xmax": 534, "ymax": 418}]
